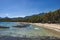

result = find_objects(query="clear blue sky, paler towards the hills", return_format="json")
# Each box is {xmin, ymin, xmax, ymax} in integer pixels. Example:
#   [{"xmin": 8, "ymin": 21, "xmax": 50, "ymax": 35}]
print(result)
[{"xmin": 0, "ymin": 0, "xmax": 60, "ymax": 18}]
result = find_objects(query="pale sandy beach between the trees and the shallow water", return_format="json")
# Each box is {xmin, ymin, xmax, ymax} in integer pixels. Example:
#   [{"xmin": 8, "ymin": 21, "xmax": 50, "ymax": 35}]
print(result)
[{"xmin": 31, "ymin": 23, "xmax": 60, "ymax": 32}]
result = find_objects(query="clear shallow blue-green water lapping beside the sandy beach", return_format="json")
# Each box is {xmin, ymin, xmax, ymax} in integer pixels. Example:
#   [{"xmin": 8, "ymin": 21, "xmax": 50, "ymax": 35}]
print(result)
[{"xmin": 0, "ymin": 22, "xmax": 60, "ymax": 37}]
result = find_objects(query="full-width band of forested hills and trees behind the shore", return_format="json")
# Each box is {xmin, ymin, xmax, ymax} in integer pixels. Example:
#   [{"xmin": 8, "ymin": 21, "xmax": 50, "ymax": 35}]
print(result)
[{"xmin": 0, "ymin": 9, "xmax": 60, "ymax": 23}]
